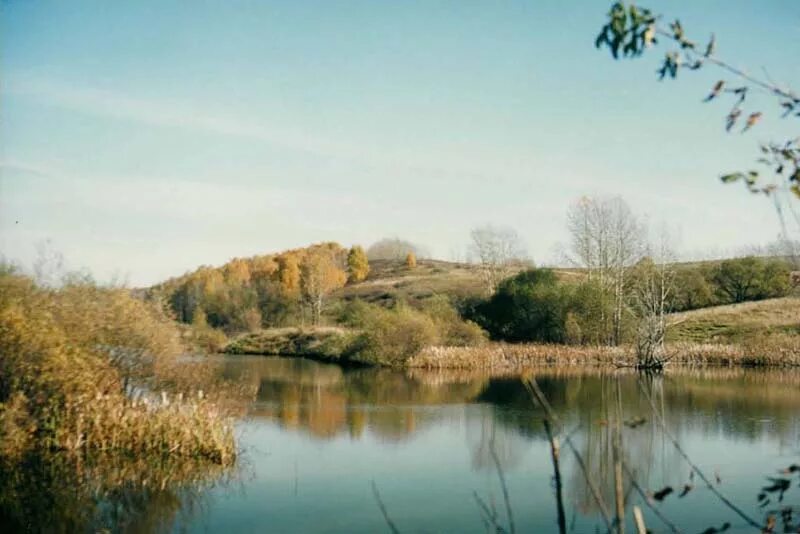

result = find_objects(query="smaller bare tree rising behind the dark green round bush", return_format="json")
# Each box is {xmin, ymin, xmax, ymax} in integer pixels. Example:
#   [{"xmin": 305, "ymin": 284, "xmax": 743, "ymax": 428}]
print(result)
[{"xmin": 470, "ymin": 225, "xmax": 525, "ymax": 294}]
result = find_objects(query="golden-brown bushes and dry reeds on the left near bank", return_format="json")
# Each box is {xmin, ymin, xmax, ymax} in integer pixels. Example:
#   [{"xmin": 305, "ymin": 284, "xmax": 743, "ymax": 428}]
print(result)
[{"xmin": 0, "ymin": 274, "xmax": 236, "ymax": 464}]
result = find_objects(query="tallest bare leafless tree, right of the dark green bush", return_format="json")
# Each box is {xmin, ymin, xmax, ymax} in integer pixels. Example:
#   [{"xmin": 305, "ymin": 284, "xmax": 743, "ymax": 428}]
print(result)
[{"xmin": 567, "ymin": 197, "xmax": 644, "ymax": 344}]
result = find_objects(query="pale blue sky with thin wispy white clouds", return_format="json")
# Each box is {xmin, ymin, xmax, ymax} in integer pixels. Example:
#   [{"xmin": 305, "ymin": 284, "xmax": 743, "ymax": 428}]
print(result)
[{"xmin": 0, "ymin": 0, "xmax": 800, "ymax": 285}]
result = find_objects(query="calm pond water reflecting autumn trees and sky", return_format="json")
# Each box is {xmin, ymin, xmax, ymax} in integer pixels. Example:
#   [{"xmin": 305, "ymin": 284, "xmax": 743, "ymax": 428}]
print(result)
[{"xmin": 7, "ymin": 357, "xmax": 800, "ymax": 532}]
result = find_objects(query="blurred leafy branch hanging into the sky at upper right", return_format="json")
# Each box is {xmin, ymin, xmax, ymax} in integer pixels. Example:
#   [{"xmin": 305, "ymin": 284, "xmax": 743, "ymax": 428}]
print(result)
[{"xmin": 595, "ymin": 2, "xmax": 800, "ymax": 203}]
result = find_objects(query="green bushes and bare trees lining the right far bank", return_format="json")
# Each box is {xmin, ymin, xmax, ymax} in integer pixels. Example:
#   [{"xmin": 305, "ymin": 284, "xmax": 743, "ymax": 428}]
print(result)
[{"xmin": 460, "ymin": 197, "xmax": 792, "ymax": 364}]
